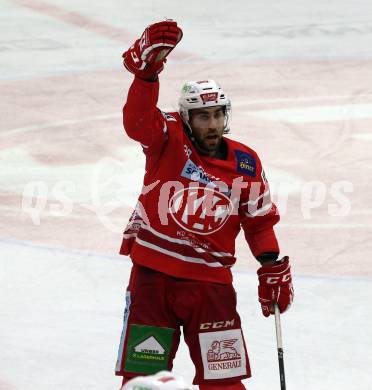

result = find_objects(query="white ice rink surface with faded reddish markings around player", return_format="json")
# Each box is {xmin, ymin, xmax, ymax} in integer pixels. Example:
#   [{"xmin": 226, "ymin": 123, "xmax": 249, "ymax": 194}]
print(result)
[{"xmin": 0, "ymin": 0, "xmax": 372, "ymax": 390}]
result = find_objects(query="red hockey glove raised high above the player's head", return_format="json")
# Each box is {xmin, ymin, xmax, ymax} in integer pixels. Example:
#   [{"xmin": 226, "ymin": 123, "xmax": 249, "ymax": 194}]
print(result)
[{"xmin": 123, "ymin": 19, "xmax": 182, "ymax": 79}]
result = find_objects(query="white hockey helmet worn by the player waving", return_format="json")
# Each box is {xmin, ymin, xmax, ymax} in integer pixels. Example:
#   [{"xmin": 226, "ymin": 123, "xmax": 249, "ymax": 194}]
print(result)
[{"xmin": 178, "ymin": 80, "xmax": 231, "ymax": 134}]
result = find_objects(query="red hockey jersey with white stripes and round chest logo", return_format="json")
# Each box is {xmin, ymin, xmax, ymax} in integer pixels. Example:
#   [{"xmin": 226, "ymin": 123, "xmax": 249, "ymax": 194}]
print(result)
[{"xmin": 120, "ymin": 78, "xmax": 279, "ymax": 283}]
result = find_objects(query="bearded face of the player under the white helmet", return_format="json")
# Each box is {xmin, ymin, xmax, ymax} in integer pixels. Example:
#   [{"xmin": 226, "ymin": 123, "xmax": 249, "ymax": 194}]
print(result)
[{"xmin": 190, "ymin": 106, "xmax": 225, "ymax": 156}]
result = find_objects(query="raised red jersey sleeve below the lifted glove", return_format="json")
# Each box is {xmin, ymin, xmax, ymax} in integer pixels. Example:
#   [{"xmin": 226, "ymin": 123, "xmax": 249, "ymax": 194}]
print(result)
[{"xmin": 123, "ymin": 78, "xmax": 168, "ymax": 155}]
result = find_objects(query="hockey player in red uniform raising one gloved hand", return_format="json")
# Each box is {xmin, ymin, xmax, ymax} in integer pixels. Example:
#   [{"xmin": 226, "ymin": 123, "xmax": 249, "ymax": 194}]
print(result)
[{"xmin": 116, "ymin": 20, "xmax": 293, "ymax": 390}]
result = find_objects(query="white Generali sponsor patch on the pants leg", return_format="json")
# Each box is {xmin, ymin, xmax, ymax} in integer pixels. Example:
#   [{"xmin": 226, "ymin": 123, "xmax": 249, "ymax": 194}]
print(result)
[{"xmin": 199, "ymin": 329, "xmax": 247, "ymax": 379}]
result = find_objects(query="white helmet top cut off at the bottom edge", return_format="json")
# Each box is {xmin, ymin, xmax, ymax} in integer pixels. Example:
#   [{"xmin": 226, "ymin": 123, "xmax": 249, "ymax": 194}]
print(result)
[{"xmin": 121, "ymin": 371, "xmax": 192, "ymax": 390}]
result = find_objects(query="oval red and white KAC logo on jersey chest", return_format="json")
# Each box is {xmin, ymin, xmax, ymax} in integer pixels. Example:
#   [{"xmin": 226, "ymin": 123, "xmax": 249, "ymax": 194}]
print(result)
[{"xmin": 168, "ymin": 187, "xmax": 234, "ymax": 235}]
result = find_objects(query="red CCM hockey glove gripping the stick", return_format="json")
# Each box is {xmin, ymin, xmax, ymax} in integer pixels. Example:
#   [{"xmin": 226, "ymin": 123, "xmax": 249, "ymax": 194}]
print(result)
[{"xmin": 257, "ymin": 256, "xmax": 294, "ymax": 317}]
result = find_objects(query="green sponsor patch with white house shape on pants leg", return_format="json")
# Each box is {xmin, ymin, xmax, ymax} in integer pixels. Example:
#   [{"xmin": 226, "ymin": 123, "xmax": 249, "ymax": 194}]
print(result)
[{"xmin": 124, "ymin": 324, "xmax": 175, "ymax": 375}]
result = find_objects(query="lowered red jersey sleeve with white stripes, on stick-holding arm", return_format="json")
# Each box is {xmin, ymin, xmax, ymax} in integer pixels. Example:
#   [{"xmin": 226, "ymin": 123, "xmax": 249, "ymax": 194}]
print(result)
[{"xmin": 239, "ymin": 152, "xmax": 280, "ymax": 258}]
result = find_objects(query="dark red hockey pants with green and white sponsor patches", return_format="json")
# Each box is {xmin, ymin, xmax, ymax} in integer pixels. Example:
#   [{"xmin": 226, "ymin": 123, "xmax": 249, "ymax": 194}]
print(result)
[{"xmin": 116, "ymin": 265, "xmax": 251, "ymax": 385}]
